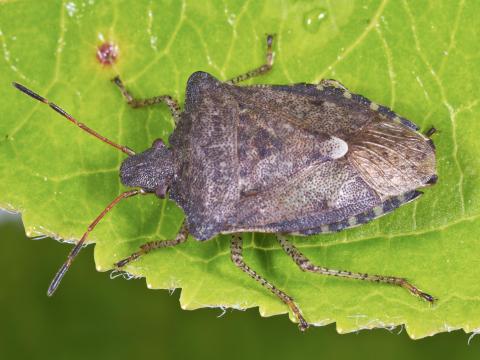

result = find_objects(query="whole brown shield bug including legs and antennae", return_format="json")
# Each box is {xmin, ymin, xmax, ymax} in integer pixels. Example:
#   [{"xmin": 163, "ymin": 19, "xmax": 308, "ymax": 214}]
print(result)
[{"xmin": 13, "ymin": 36, "xmax": 437, "ymax": 330}]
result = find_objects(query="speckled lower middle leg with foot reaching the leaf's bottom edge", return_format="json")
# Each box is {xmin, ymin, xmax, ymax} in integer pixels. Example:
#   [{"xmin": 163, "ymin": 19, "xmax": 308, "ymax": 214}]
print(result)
[{"xmin": 231, "ymin": 234, "xmax": 308, "ymax": 331}]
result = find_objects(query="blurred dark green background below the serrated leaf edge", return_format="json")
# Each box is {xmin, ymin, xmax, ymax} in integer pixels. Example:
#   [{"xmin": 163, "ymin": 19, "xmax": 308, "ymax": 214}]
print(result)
[{"xmin": 0, "ymin": 213, "xmax": 480, "ymax": 360}]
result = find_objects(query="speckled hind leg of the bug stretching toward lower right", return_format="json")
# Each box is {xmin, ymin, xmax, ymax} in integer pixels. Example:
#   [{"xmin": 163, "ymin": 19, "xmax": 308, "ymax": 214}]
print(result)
[{"xmin": 277, "ymin": 235, "xmax": 435, "ymax": 303}]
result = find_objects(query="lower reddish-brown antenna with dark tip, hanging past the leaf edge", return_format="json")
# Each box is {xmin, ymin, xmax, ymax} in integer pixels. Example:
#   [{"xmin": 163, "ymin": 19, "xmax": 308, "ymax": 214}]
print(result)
[{"xmin": 47, "ymin": 189, "xmax": 145, "ymax": 296}]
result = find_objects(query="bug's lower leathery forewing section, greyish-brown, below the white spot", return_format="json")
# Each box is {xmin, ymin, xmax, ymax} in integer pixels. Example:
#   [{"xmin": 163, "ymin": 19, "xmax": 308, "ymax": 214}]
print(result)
[{"xmin": 229, "ymin": 159, "xmax": 380, "ymax": 232}]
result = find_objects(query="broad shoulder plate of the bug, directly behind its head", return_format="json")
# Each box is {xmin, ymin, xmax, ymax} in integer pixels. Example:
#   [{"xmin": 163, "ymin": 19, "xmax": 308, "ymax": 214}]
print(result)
[{"xmin": 170, "ymin": 73, "xmax": 240, "ymax": 239}]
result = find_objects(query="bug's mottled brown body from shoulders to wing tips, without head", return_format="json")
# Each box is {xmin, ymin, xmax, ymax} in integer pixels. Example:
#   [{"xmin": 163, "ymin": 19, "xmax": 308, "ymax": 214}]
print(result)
[{"xmin": 170, "ymin": 72, "xmax": 435, "ymax": 240}]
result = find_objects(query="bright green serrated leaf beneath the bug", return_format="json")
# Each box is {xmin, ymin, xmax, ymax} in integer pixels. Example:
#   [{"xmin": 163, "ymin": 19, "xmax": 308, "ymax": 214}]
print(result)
[{"xmin": 0, "ymin": 0, "xmax": 480, "ymax": 338}]
